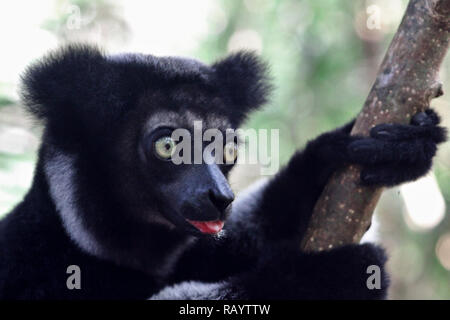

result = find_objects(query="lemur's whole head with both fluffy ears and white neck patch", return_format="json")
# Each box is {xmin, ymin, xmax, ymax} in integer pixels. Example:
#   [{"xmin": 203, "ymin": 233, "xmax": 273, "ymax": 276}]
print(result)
[{"xmin": 22, "ymin": 46, "xmax": 270, "ymax": 255}]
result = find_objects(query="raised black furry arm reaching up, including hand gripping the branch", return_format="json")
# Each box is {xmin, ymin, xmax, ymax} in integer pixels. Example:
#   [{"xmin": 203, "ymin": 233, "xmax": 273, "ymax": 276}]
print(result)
[{"xmin": 241, "ymin": 109, "xmax": 446, "ymax": 241}]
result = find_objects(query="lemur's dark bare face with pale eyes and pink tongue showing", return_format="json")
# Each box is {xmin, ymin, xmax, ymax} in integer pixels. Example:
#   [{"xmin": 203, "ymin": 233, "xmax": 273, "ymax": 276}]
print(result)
[{"xmin": 121, "ymin": 85, "xmax": 238, "ymax": 235}]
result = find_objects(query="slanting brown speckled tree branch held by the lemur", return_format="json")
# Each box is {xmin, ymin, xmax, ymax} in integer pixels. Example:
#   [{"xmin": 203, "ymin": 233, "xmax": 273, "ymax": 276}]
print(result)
[{"xmin": 302, "ymin": 0, "xmax": 450, "ymax": 251}]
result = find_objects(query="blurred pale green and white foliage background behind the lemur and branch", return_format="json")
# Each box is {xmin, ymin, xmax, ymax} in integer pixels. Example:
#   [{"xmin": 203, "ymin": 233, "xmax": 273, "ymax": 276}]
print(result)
[{"xmin": 0, "ymin": 0, "xmax": 450, "ymax": 299}]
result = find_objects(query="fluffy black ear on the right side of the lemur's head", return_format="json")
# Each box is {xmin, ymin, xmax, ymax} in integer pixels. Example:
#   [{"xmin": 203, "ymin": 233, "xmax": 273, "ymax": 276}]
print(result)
[{"xmin": 212, "ymin": 51, "xmax": 272, "ymax": 120}]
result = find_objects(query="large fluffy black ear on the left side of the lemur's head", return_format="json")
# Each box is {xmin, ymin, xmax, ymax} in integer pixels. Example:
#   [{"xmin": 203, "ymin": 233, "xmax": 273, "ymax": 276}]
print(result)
[{"xmin": 20, "ymin": 45, "xmax": 110, "ymax": 124}]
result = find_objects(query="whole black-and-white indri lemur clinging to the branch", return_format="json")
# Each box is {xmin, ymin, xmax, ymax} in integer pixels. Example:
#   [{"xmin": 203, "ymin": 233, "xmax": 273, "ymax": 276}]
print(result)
[{"xmin": 0, "ymin": 45, "xmax": 446, "ymax": 299}]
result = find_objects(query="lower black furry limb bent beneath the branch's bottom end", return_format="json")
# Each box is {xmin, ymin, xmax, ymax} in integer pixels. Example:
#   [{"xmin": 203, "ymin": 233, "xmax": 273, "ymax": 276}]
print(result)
[{"xmin": 235, "ymin": 244, "xmax": 389, "ymax": 300}]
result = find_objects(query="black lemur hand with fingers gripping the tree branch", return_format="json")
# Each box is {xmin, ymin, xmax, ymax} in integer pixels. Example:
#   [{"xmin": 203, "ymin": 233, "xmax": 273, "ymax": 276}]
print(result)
[{"xmin": 347, "ymin": 109, "xmax": 447, "ymax": 186}]
